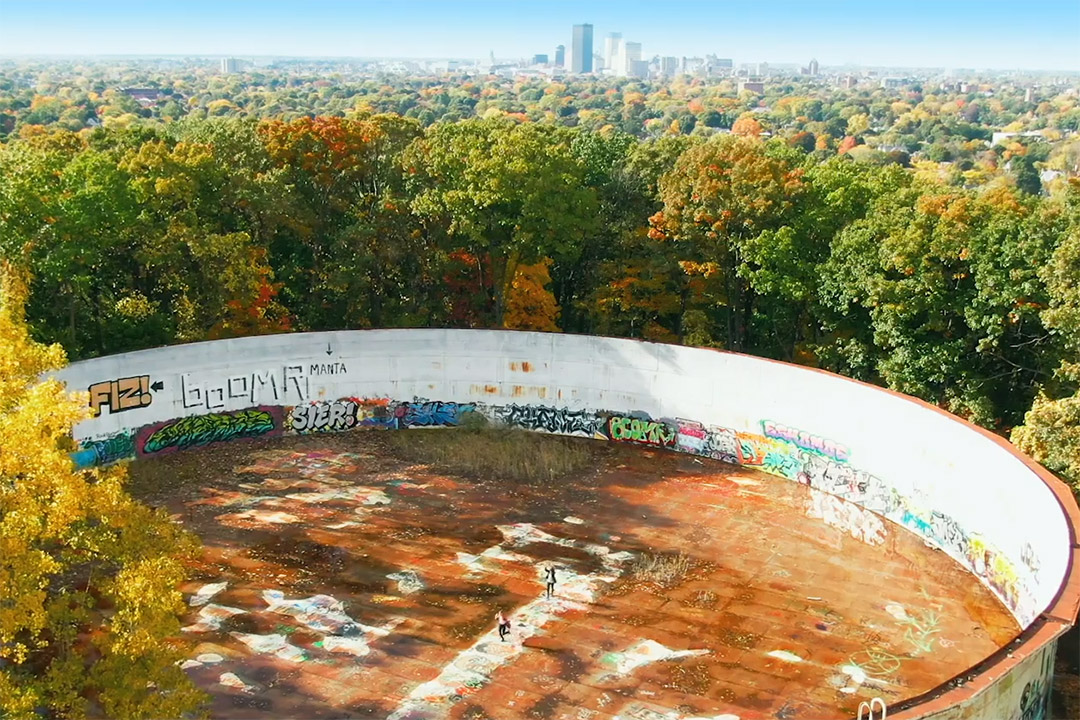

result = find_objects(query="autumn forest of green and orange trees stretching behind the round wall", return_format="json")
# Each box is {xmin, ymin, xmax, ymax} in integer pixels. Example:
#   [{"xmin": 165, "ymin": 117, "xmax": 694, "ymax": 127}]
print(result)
[{"xmin": 0, "ymin": 66, "xmax": 1080, "ymax": 496}]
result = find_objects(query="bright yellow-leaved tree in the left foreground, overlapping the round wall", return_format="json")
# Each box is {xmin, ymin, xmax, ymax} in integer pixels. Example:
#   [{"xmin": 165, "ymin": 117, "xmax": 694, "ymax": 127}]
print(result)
[{"xmin": 0, "ymin": 266, "xmax": 203, "ymax": 719}]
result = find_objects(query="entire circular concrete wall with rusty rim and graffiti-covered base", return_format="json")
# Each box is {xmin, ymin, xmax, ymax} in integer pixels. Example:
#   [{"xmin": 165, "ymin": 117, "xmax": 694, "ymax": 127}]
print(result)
[{"xmin": 57, "ymin": 329, "xmax": 1080, "ymax": 720}]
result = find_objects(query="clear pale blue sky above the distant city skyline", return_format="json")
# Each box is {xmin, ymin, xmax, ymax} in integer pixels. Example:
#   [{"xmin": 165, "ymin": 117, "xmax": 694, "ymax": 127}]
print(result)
[{"xmin": 0, "ymin": 0, "xmax": 1080, "ymax": 70}]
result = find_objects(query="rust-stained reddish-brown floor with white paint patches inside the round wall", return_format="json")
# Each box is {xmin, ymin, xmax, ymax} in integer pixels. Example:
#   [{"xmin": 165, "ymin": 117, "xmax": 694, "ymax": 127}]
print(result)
[{"xmin": 133, "ymin": 433, "xmax": 1018, "ymax": 720}]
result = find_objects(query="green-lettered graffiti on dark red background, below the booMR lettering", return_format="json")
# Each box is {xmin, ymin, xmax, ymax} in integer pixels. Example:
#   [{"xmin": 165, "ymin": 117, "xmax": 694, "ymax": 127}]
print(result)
[{"xmin": 136, "ymin": 407, "xmax": 281, "ymax": 454}]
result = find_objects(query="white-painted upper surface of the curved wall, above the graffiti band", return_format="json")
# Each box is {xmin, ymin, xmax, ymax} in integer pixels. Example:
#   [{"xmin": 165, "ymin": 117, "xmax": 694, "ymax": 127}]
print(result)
[{"xmin": 58, "ymin": 330, "xmax": 1070, "ymax": 625}]
